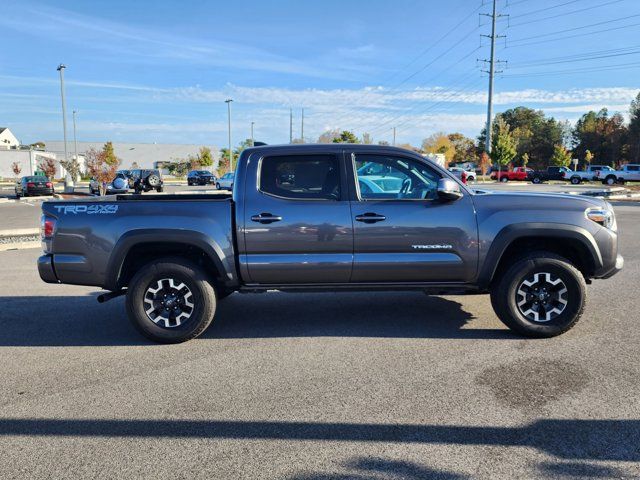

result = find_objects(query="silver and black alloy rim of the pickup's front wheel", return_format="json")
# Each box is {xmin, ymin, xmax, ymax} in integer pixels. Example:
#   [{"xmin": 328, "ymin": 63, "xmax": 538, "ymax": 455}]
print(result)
[{"xmin": 516, "ymin": 272, "xmax": 568, "ymax": 323}]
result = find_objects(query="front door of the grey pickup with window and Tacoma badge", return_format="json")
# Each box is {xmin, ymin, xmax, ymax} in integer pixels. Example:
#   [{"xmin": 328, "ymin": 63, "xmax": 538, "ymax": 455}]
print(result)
[{"xmin": 351, "ymin": 155, "xmax": 478, "ymax": 282}]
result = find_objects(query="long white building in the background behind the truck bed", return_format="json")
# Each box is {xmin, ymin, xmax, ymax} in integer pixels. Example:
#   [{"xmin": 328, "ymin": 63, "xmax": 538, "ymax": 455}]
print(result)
[{"xmin": 44, "ymin": 140, "xmax": 220, "ymax": 173}]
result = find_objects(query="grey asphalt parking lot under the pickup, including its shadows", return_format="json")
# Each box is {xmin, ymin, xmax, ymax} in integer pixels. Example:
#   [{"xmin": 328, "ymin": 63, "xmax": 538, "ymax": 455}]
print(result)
[{"xmin": 0, "ymin": 196, "xmax": 640, "ymax": 480}]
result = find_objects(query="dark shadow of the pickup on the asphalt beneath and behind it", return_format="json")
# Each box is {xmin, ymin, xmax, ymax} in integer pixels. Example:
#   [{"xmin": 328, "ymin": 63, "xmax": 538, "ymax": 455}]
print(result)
[{"xmin": 0, "ymin": 292, "xmax": 518, "ymax": 347}]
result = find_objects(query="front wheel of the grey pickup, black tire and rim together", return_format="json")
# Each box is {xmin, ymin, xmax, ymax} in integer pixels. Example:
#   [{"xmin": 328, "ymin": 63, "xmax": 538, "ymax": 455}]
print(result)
[{"xmin": 491, "ymin": 251, "xmax": 586, "ymax": 338}]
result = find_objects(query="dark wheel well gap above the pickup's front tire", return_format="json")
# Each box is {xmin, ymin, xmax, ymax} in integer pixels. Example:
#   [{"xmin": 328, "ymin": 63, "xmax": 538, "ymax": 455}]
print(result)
[{"xmin": 492, "ymin": 236, "xmax": 596, "ymax": 281}]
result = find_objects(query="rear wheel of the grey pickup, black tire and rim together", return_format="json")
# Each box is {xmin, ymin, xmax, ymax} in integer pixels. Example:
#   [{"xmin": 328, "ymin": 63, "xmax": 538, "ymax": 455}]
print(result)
[{"xmin": 126, "ymin": 257, "xmax": 217, "ymax": 343}]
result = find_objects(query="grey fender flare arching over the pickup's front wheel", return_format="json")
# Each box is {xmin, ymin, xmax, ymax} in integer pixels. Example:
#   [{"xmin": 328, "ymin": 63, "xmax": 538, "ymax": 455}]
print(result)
[{"xmin": 478, "ymin": 222, "xmax": 603, "ymax": 289}]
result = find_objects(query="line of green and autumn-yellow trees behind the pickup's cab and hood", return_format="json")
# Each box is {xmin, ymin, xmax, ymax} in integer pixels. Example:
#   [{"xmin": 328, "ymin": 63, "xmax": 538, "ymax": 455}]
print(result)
[{"xmin": 318, "ymin": 93, "xmax": 640, "ymax": 171}]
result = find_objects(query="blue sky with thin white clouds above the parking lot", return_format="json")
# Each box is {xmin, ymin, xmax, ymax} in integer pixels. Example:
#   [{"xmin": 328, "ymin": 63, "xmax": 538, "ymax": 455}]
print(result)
[{"xmin": 0, "ymin": 0, "xmax": 640, "ymax": 146}]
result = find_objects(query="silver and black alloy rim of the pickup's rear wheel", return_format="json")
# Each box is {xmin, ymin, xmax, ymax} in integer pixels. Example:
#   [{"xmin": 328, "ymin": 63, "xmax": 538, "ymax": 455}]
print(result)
[{"xmin": 142, "ymin": 278, "xmax": 195, "ymax": 328}]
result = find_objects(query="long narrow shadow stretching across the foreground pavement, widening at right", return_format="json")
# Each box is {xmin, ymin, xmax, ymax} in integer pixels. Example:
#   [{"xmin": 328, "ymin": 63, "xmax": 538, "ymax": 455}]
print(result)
[{"xmin": 0, "ymin": 418, "xmax": 640, "ymax": 464}]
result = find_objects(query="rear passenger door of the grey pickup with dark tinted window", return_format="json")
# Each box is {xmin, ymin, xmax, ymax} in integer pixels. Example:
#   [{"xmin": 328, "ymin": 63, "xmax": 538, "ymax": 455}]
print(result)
[{"xmin": 243, "ymin": 154, "xmax": 353, "ymax": 284}]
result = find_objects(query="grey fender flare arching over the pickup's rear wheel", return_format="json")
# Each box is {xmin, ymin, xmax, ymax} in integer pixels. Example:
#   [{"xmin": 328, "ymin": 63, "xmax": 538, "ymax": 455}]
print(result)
[{"xmin": 105, "ymin": 228, "xmax": 235, "ymax": 291}]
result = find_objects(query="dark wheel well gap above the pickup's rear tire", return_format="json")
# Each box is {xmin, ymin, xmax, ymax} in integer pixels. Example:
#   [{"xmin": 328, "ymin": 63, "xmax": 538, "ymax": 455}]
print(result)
[{"xmin": 118, "ymin": 242, "xmax": 221, "ymax": 288}]
